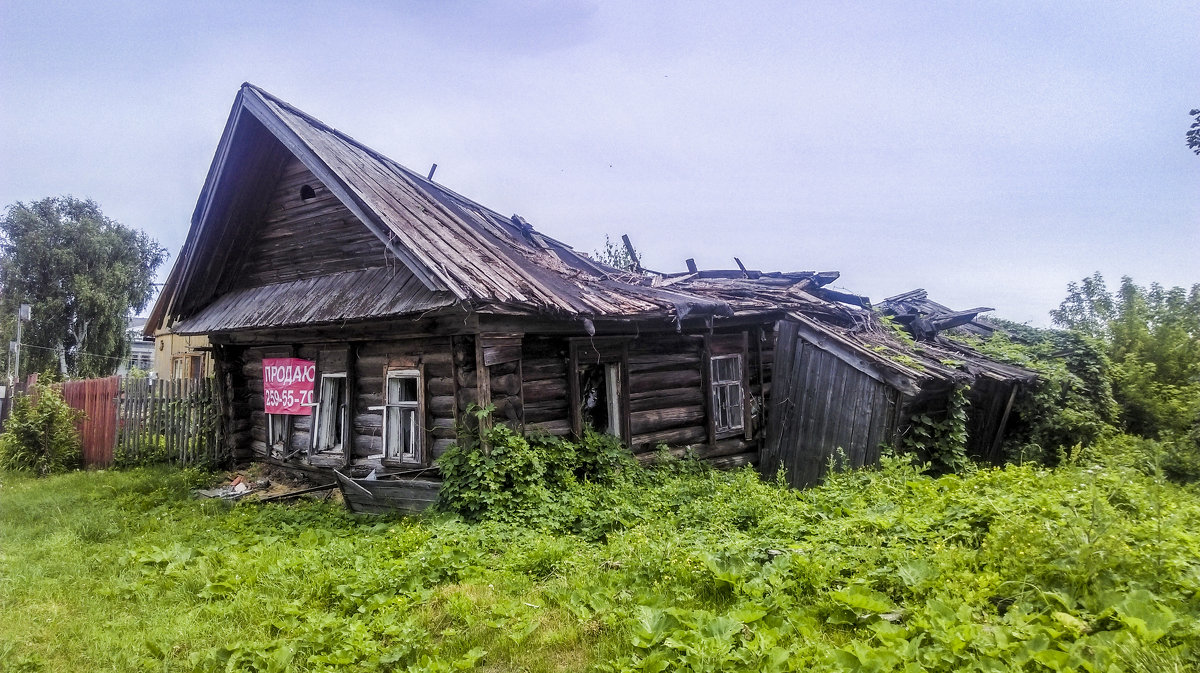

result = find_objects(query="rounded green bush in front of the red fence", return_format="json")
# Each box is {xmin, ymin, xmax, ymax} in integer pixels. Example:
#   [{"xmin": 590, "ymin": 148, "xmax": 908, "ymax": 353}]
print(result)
[{"xmin": 0, "ymin": 386, "xmax": 83, "ymax": 476}]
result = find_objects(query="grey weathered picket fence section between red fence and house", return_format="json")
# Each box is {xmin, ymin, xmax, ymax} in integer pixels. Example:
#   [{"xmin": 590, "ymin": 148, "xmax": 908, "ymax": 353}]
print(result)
[{"xmin": 115, "ymin": 378, "xmax": 222, "ymax": 465}]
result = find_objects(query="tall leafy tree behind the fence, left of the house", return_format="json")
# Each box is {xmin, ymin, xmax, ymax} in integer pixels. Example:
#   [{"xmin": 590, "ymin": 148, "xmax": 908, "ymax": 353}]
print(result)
[{"xmin": 0, "ymin": 197, "xmax": 167, "ymax": 377}]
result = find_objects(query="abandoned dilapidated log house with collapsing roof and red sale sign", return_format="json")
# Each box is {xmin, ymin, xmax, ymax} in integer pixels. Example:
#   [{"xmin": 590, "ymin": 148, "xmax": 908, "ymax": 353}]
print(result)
[{"xmin": 148, "ymin": 84, "xmax": 1028, "ymax": 509}]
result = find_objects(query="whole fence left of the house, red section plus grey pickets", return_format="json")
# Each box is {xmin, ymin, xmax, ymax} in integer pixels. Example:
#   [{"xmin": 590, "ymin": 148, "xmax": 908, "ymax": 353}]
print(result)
[{"xmin": 62, "ymin": 377, "xmax": 223, "ymax": 467}]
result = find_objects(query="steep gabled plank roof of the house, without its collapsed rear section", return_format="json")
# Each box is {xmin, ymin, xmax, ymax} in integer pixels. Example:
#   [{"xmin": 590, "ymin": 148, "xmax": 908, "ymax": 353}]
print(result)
[{"xmin": 148, "ymin": 84, "xmax": 836, "ymax": 334}]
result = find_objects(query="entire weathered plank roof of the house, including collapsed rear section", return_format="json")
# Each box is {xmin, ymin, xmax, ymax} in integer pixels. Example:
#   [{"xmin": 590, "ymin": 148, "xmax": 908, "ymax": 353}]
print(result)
[{"xmin": 146, "ymin": 84, "xmax": 1032, "ymax": 392}]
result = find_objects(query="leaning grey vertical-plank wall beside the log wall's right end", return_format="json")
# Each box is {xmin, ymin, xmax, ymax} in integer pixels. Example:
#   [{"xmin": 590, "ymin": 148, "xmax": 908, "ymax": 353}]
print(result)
[{"xmin": 760, "ymin": 322, "xmax": 901, "ymax": 487}]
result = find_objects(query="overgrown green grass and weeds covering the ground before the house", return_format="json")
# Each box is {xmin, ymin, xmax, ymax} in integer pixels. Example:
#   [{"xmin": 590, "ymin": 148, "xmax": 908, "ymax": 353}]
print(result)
[{"xmin": 0, "ymin": 441, "xmax": 1200, "ymax": 672}]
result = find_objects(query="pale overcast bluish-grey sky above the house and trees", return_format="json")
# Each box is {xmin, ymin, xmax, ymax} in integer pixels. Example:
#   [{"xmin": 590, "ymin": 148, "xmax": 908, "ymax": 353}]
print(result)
[{"xmin": 0, "ymin": 0, "xmax": 1200, "ymax": 325}]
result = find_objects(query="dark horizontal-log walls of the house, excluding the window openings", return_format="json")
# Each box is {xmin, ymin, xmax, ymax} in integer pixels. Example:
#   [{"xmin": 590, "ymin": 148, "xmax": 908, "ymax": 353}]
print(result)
[{"xmin": 218, "ymin": 319, "xmax": 775, "ymax": 469}]
